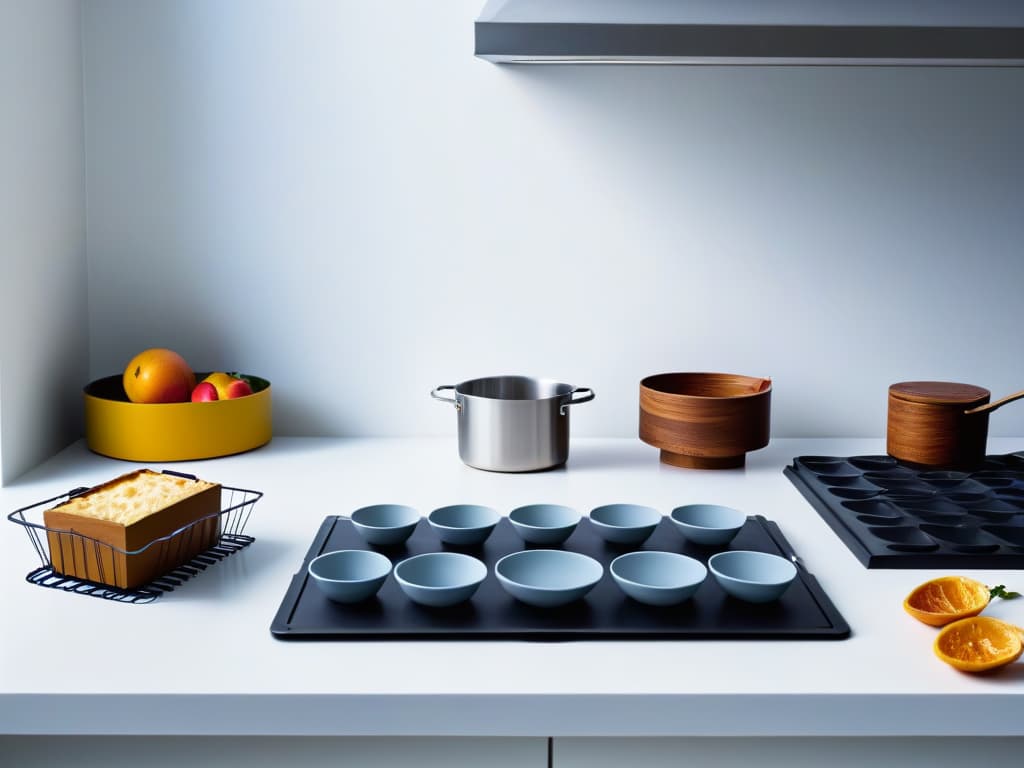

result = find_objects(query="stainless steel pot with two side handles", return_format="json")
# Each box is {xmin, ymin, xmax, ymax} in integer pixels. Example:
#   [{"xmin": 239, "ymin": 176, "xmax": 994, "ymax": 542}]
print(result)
[{"xmin": 430, "ymin": 376, "xmax": 594, "ymax": 472}]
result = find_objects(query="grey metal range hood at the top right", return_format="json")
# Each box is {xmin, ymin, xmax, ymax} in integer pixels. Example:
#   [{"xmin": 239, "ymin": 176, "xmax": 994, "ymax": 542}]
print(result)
[{"xmin": 476, "ymin": 0, "xmax": 1024, "ymax": 67}]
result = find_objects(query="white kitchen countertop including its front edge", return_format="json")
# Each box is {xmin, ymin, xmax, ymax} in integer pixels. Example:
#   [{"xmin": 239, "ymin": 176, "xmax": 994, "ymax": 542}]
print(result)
[{"xmin": 0, "ymin": 437, "xmax": 1024, "ymax": 736}]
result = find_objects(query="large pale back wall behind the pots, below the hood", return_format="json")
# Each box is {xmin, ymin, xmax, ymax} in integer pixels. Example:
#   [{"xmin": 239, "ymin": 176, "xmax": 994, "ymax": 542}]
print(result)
[{"xmin": 84, "ymin": 0, "xmax": 1024, "ymax": 436}]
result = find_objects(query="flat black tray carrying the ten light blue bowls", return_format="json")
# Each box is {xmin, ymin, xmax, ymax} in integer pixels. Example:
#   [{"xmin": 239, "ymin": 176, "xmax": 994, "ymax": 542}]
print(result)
[{"xmin": 270, "ymin": 516, "xmax": 850, "ymax": 640}]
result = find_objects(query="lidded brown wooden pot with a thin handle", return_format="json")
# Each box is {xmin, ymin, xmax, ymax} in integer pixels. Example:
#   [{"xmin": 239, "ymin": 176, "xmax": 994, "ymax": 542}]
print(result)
[{"xmin": 886, "ymin": 381, "xmax": 1024, "ymax": 469}]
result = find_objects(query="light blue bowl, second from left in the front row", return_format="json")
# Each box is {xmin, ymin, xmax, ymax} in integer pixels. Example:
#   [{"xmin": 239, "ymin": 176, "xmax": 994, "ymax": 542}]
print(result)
[{"xmin": 394, "ymin": 552, "xmax": 487, "ymax": 608}]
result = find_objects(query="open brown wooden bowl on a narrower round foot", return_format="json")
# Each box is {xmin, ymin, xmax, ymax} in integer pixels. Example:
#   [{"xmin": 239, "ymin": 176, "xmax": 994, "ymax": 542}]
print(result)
[{"xmin": 640, "ymin": 373, "xmax": 771, "ymax": 469}]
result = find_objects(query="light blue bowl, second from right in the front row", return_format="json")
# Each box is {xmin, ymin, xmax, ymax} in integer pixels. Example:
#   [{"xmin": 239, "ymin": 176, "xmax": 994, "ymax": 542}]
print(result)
[{"xmin": 608, "ymin": 550, "xmax": 708, "ymax": 605}]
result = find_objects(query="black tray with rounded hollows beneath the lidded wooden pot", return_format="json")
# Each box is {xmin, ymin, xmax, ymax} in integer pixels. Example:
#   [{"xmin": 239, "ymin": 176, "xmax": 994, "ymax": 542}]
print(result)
[{"xmin": 784, "ymin": 454, "xmax": 1024, "ymax": 568}]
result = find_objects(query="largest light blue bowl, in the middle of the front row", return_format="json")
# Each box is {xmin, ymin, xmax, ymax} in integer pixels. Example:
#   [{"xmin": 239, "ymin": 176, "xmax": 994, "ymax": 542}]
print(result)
[{"xmin": 495, "ymin": 549, "xmax": 604, "ymax": 608}]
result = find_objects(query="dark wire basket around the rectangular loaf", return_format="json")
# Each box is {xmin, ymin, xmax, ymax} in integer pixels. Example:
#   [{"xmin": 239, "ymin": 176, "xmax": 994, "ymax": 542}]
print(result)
[{"xmin": 7, "ymin": 470, "xmax": 263, "ymax": 603}]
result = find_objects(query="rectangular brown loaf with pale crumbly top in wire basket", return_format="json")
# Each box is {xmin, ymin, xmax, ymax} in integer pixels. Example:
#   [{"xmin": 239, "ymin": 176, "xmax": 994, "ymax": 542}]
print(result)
[{"xmin": 43, "ymin": 469, "xmax": 220, "ymax": 589}]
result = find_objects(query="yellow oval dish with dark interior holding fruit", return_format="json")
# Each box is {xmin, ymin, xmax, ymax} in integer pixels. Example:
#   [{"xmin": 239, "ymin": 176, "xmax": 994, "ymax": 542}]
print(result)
[{"xmin": 83, "ymin": 373, "xmax": 271, "ymax": 462}]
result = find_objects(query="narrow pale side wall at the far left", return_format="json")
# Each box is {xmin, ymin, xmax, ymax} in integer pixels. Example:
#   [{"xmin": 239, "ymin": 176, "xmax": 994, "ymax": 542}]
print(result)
[{"xmin": 0, "ymin": 0, "xmax": 89, "ymax": 483}]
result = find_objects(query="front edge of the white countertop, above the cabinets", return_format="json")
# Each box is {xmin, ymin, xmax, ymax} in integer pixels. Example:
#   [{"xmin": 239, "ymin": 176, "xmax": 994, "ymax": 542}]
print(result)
[{"xmin": 0, "ymin": 693, "xmax": 1024, "ymax": 737}]
